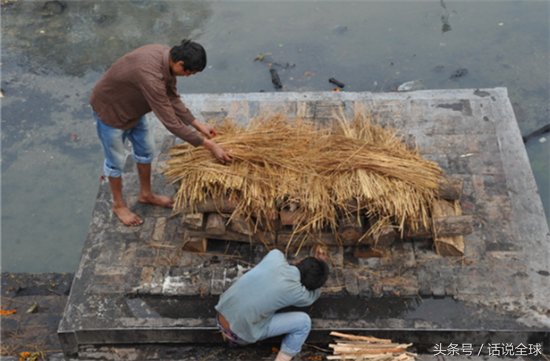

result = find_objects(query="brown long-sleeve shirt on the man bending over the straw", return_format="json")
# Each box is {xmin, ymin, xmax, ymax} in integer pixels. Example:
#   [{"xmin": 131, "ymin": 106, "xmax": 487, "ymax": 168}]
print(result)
[{"xmin": 90, "ymin": 45, "xmax": 204, "ymax": 146}]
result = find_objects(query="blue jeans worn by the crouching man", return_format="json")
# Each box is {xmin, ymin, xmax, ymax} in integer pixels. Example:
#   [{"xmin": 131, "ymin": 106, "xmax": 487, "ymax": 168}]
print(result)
[{"xmin": 260, "ymin": 311, "xmax": 311, "ymax": 356}]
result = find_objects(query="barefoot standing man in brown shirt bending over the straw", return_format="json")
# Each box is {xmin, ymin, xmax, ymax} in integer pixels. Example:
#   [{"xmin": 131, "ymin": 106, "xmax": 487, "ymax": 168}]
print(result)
[{"xmin": 90, "ymin": 40, "xmax": 231, "ymax": 226}]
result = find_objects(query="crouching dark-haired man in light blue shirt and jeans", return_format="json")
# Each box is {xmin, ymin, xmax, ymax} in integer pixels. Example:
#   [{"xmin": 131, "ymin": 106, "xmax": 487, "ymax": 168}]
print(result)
[{"xmin": 215, "ymin": 250, "xmax": 329, "ymax": 361}]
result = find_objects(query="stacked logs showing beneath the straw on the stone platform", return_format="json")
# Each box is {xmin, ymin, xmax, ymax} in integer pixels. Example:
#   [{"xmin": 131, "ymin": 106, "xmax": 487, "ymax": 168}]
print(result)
[{"xmin": 182, "ymin": 173, "xmax": 472, "ymax": 256}]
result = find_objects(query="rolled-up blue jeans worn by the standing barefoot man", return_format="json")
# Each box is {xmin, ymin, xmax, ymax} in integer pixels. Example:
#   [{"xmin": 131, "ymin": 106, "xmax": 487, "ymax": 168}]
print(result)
[{"xmin": 93, "ymin": 112, "xmax": 154, "ymax": 178}]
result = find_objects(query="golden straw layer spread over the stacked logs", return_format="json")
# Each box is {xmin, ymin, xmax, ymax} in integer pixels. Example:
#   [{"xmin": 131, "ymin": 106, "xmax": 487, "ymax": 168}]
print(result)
[{"xmin": 165, "ymin": 114, "xmax": 441, "ymax": 248}]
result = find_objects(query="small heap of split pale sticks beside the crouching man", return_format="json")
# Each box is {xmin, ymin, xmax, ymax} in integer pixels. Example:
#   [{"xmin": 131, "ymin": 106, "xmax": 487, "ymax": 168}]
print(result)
[{"xmin": 327, "ymin": 332, "xmax": 417, "ymax": 361}]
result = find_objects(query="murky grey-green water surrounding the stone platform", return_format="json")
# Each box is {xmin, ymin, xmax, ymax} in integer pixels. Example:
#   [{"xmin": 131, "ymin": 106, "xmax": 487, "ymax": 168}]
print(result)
[{"xmin": 1, "ymin": 0, "xmax": 550, "ymax": 272}]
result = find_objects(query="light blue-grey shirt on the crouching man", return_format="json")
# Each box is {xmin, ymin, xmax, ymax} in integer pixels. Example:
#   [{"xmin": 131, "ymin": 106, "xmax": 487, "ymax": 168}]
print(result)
[{"xmin": 215, "ymin": 249, "xmax": 321, "ymax": 343}]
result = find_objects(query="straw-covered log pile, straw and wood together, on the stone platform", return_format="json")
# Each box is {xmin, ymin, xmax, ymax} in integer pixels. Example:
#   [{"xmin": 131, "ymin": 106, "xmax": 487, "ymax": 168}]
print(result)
[{"xmin": 165, "ymin": 114, "xmax": 472, "ymax": 256}]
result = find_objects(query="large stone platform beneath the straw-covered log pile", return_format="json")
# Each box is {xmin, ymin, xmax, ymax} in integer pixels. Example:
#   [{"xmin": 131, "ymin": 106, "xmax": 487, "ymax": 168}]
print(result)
[{"xmin": 58, "ymin": 88, "xmax": 550, "ymax": 356}]
